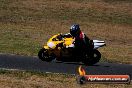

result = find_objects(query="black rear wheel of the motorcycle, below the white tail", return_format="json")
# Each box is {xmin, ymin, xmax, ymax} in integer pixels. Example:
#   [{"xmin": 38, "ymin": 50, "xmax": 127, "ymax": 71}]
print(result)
[{"xmin": 83, "ymin": 50, "xmax": 101, "ymax": 65}]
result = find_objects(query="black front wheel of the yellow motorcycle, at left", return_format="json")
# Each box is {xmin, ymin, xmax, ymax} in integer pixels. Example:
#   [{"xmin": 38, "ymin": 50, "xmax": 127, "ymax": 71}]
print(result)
[{"xmin": 38, "ymin": 48, "xmax": 55, "ymax": 62}]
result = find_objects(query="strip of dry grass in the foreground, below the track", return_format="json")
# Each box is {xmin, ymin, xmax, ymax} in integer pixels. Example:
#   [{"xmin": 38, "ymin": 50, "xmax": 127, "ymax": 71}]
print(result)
[{"xmin": 0, "ymin": 69, "xmax": 132, "ymax": 88}]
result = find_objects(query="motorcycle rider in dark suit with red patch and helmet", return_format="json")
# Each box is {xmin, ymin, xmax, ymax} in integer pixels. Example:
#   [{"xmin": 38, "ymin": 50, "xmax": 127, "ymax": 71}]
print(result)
[{"xmin": 70, "ymin": 24, "xmax": 90, "ymax": 54}]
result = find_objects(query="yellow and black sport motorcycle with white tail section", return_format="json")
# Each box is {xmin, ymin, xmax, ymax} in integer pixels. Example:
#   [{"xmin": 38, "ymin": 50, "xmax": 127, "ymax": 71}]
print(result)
[{"xmin": 38, "ymin": 34, "xmax": 106, "ymax": 65}]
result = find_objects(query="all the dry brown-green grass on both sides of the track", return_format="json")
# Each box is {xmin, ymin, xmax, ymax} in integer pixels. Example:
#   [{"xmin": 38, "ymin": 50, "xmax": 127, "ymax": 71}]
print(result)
[{"xmin": 0, "ymin": 0, "xmax": 132, "ymax": 88}]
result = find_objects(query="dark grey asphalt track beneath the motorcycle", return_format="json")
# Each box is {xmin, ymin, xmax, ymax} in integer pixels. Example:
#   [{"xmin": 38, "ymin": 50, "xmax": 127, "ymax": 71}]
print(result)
[{"xmin": 0, "ymin": 54, "xmax": 132, "ymax": 78}]
